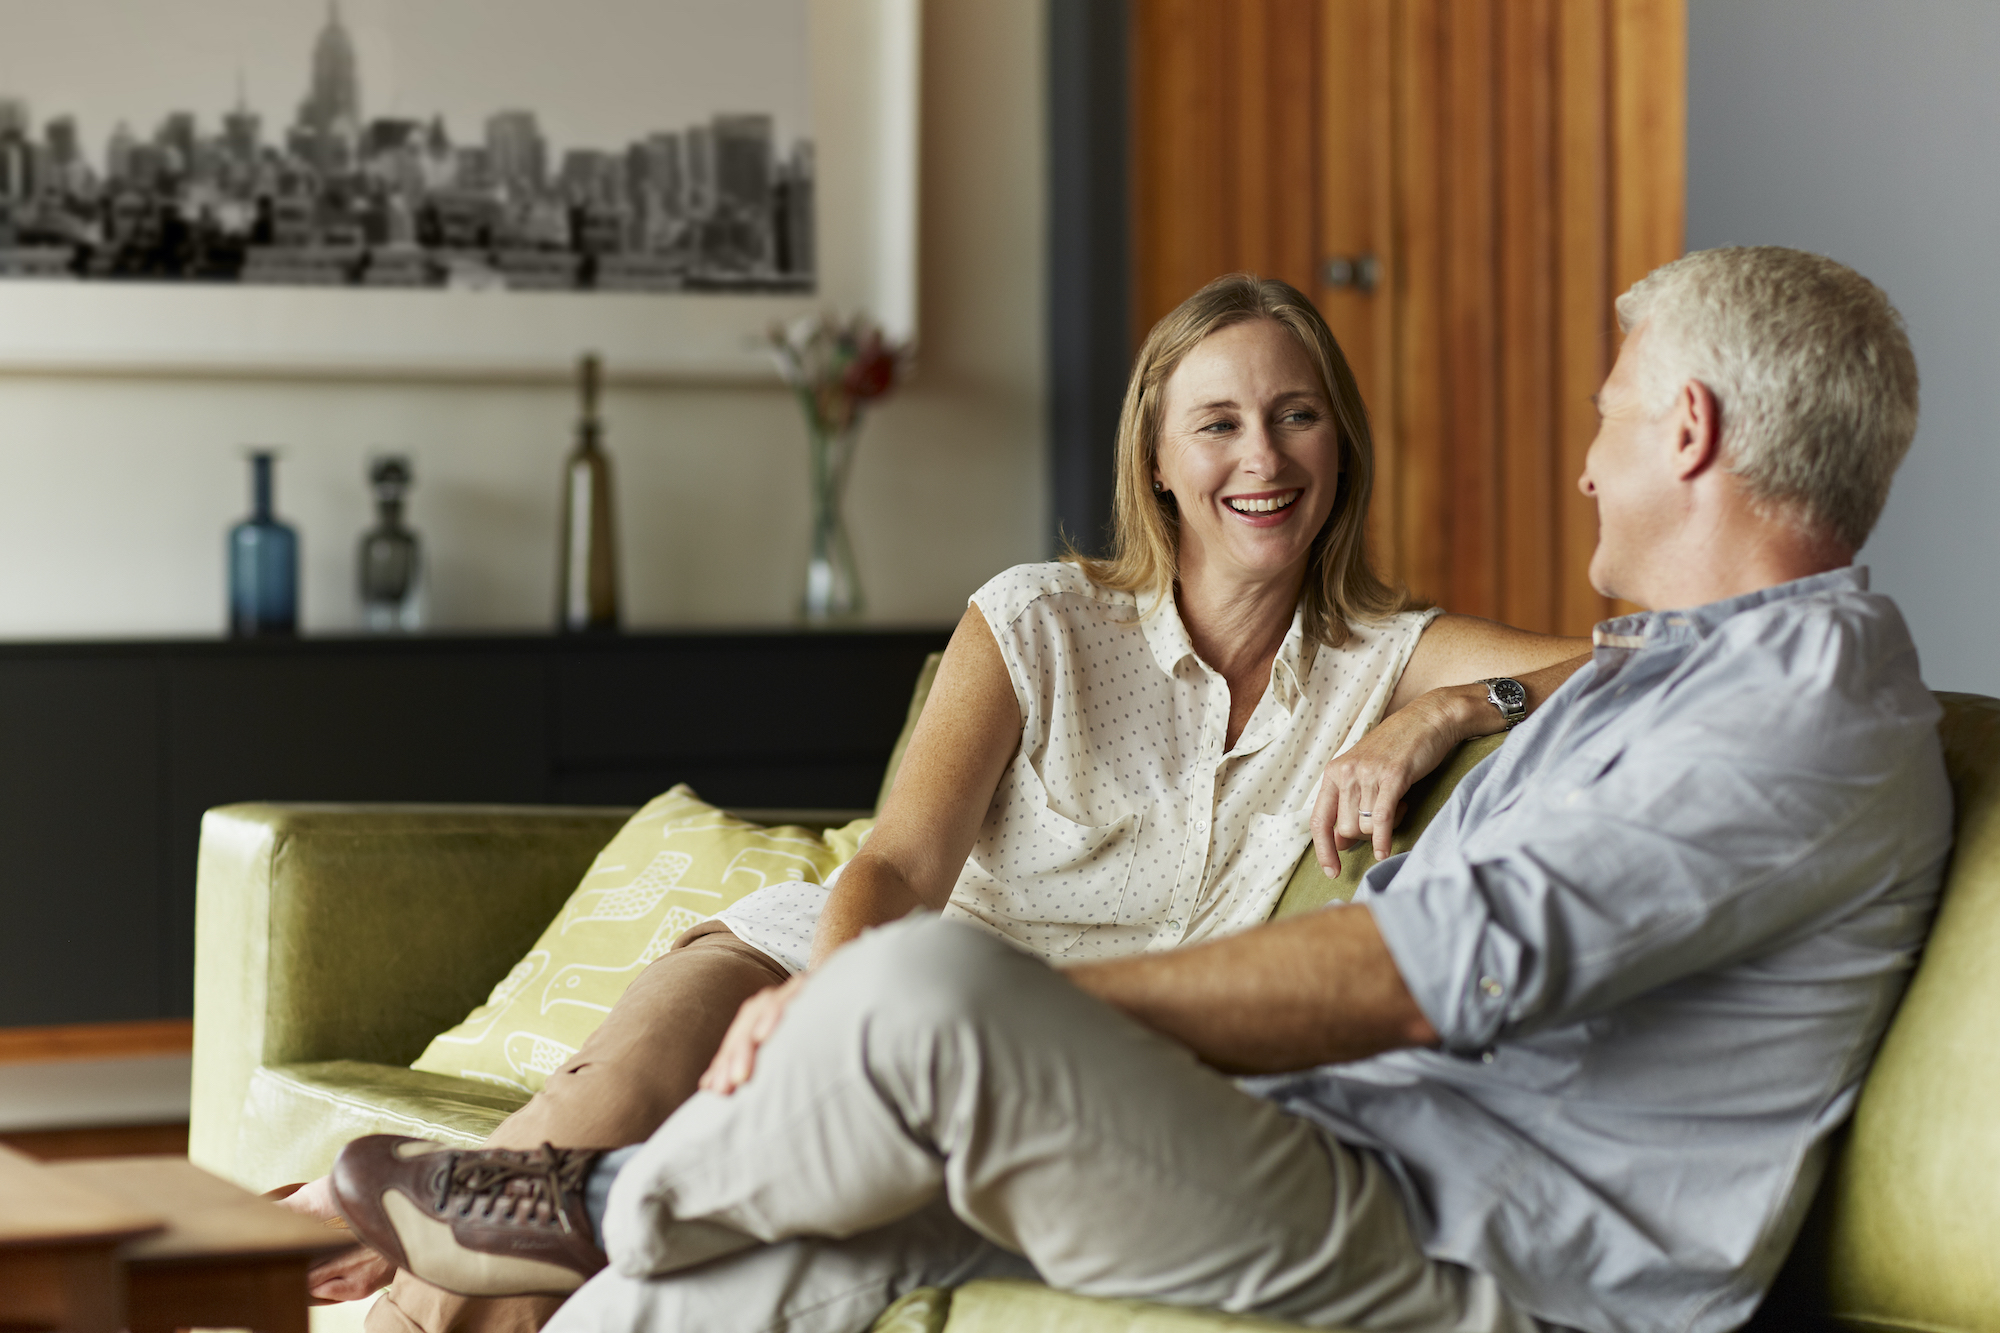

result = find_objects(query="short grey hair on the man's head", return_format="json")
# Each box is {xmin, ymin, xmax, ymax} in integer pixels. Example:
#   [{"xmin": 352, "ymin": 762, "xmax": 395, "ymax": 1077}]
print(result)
[{"xmin": 1618, "ymin": 246, "xmax": 1916, "ymax": 550}]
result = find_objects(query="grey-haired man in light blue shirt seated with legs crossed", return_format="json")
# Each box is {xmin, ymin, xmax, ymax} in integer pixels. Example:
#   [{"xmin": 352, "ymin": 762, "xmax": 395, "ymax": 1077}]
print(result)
[{"xmin": 334, "ymin": 248, "xmax": 1950, "ymax": 1333}]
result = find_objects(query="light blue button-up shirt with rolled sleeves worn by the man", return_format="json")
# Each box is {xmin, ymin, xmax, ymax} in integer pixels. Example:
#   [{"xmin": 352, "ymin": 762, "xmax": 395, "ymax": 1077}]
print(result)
[{"xmin": 1248, "ymin": 568, "xmax": 1952, "ymax": 1333}]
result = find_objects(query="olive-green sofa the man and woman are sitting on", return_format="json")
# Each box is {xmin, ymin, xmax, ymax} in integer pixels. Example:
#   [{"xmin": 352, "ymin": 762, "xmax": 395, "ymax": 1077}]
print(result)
[{"xmin": 190, "ymin": 671, "xmax": 2000, "ymax": 1333}]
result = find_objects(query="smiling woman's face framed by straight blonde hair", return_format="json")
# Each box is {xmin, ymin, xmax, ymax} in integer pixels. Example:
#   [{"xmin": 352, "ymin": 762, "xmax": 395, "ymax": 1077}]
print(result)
[{"xmin": 1154, "ymin": 318, "xmax": 1340, "ymax": 582}]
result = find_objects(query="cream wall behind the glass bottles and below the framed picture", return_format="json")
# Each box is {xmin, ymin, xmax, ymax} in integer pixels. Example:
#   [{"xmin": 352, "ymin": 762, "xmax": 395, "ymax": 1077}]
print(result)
[{"xmin": 0, "ymin": 0, "xmax": 1048, "ymax": 638}]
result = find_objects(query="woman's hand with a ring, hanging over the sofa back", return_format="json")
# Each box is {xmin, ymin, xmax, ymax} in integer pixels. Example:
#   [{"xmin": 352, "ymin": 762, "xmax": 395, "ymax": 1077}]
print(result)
[{"xmin": 1312, "ymin": 687, "xmax": 1484, "ymax": 875}]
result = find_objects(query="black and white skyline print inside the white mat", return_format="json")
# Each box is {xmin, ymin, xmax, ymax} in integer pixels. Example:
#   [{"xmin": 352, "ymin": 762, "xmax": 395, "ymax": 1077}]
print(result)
[{"xmin": 0, "ymin": 0, "xmax": 814, "ymax": 292}]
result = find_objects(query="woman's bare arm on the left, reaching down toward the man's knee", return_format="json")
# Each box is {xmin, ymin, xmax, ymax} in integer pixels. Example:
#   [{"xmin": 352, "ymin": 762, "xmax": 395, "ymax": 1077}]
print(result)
[{"xmin": 812, "ymin": 606, "xmax": 1022, "ymax": 967}]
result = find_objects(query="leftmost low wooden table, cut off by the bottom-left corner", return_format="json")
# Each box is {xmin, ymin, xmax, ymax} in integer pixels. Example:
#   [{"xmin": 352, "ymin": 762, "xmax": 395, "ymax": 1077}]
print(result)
[{"xmin": 0, "ymin": 1147, "xmax": 164, "ymax": 1333}]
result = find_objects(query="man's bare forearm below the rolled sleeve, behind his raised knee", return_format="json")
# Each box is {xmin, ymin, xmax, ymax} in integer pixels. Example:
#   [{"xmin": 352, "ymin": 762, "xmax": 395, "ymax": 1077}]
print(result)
[{"xmin": 1064, "ymin": 907, "xmax": 1438, "ymax": 1073}]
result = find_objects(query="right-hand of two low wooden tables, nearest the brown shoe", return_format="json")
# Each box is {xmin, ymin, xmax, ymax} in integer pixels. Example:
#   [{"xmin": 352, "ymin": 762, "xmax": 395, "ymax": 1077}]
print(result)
[{"xmin": 42, "ymin": 1157, "xmax": 354, "ymax": 1333}]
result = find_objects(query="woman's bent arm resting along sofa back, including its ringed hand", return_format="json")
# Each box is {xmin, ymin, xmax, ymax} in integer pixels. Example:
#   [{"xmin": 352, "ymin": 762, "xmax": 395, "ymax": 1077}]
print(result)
[{"xmin": 1312, "ymin": 614, "xmax": 1590, "ymax": 875}]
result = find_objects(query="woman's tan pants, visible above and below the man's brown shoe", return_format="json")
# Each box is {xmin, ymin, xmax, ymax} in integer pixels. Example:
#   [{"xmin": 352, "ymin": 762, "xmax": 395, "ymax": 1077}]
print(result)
[{"xmin": 368, "ymin": 923, "xmax": 786, "ymax": 1333}]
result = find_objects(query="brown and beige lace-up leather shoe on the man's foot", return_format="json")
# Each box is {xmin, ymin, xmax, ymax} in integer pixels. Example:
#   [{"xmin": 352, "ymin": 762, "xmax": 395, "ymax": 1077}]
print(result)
[{"xmin": 332, "ymin": 1135, "xmax": 606, "ymax": 1297}]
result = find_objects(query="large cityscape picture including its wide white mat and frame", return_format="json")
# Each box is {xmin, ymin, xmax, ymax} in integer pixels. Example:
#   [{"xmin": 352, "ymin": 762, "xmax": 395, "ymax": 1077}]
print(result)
[{"xmin": 0, "ymin": 0, "xmax": 918, "ymax": 380}]
